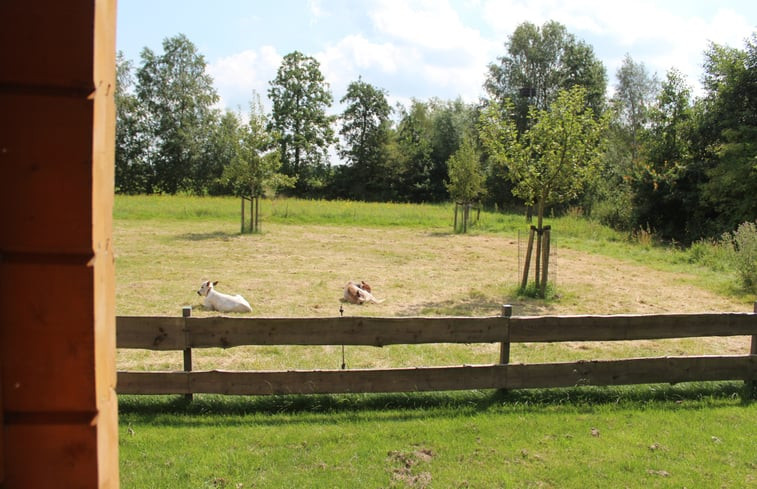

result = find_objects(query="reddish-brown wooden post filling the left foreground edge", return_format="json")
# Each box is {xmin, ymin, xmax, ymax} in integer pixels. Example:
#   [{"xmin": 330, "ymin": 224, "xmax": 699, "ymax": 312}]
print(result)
[{"xmin": 0, "ymin": 0, "xmax": 119, "ymax": 489}]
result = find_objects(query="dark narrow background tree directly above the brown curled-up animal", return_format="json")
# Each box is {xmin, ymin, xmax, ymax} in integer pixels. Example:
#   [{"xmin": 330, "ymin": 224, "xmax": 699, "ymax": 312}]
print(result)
[{"xmin": 339, "ymin": 79, "xmax": 392, "ymax": 200}]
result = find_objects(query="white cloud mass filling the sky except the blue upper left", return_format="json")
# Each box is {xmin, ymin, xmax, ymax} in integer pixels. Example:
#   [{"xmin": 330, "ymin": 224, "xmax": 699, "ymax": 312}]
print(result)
[{"xmin": 192, "ymin": 0, "xmax": 754, "ymax": 112}]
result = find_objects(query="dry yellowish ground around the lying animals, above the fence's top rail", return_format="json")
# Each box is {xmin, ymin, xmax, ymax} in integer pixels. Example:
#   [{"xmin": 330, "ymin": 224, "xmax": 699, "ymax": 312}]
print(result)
[{"xmin": 114, "ymin": 221, "xmax": 744, "ymax": 317}]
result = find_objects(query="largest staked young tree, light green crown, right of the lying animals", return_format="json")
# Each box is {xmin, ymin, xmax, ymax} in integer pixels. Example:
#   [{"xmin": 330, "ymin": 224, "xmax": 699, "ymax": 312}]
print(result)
[{"xmin": 481, "ymin": 86, "xmax": 607, "ymax": 295}]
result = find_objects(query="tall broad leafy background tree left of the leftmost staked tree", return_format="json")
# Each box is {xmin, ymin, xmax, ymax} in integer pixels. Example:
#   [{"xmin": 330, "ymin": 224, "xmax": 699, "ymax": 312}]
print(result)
[{"xmin": 137, "ymin": 34, "xmax": 218, "ymax": 194}]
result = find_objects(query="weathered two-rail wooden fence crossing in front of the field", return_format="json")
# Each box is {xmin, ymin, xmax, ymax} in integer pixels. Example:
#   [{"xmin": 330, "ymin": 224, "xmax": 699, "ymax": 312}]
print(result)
[{"xmin": 116, "ymin": 306, "xmax": 757, "ymax": 396}]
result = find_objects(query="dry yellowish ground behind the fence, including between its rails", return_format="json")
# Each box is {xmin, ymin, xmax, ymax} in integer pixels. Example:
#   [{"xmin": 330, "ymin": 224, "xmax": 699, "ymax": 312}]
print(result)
[{"xmin": 114, "ymin": 221, "xmax": 749, "ymax": 369}]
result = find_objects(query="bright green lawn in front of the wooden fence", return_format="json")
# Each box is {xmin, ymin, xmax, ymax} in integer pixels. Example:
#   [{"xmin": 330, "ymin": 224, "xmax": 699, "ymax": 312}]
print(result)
[{"xmin": 120, "ymin": 383, "xmax": 757, "ymax": 489}]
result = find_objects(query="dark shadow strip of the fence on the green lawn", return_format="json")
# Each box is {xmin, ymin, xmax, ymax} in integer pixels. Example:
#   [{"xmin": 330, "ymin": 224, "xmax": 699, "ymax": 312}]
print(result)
[{"xmin": 119, "ymin": 382, "xmax": 753, "ymax": 424}]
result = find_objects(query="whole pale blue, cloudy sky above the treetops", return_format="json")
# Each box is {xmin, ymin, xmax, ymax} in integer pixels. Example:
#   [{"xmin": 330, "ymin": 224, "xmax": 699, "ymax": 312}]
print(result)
[{"xmin": 116, "ymin": 0, "xmax": 757, "ymax": 113}]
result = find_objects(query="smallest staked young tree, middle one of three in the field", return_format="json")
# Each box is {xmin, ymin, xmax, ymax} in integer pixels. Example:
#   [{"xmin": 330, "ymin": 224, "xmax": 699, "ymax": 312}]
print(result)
[{"xmin": 446, "ymin": 136, "xmax": 484, "ymax": 232}]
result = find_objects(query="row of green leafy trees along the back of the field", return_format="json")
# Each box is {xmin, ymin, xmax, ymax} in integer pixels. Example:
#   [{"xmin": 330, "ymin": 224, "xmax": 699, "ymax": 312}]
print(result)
[{"xmin": 116, "ymin": 21, "xmax": 757, "ymax": 243}]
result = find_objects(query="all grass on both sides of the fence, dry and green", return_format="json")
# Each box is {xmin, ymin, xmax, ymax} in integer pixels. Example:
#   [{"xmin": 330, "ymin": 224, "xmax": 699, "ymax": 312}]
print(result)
[{"xmin": 114, "ymin": 196, "xmax": 757, "ymax": 488}]
